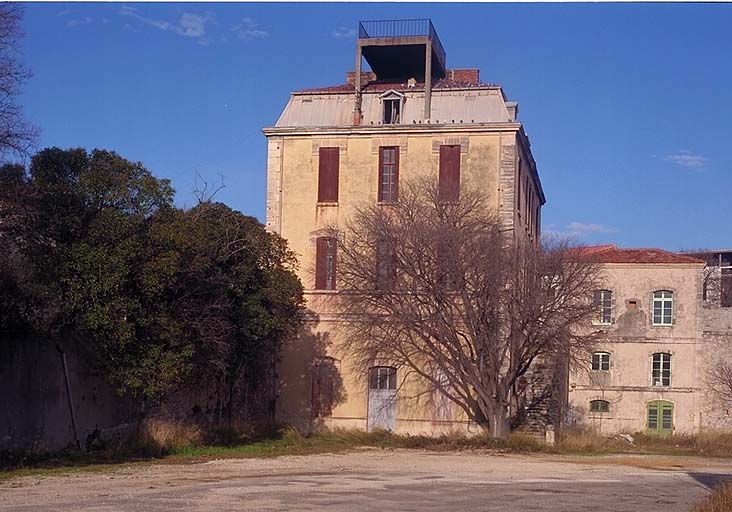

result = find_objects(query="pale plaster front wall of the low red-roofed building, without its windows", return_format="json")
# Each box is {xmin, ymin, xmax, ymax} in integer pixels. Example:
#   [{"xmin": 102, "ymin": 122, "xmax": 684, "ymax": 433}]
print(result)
[{"xmin": 569, "ymin": 264, "xmax": 703, "ymax": 433}]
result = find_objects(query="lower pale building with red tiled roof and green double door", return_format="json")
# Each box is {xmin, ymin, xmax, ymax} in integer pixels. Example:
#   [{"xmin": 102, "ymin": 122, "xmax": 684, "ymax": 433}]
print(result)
[{"xmin": 568, "ymin": 245, "xmax": 732, "ymax": 435}]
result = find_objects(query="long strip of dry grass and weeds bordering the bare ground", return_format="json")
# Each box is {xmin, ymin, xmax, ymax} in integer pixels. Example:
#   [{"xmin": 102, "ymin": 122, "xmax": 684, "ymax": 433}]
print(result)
[{"xmin": 7, "ymin": 419, "xmax": 732, "ymax": 482}]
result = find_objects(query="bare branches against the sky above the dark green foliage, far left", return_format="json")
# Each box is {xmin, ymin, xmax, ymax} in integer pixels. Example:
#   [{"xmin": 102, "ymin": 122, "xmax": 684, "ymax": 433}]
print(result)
[{"xmin": 0, "ymin": 2, "xmax": 38, "ymax": 157}]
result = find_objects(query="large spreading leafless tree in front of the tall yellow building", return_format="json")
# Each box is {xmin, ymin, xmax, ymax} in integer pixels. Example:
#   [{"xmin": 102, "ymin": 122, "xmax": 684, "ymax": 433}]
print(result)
[{"xmin": 330, "ymin": 181, "xmax": 599, "ymax": 439}]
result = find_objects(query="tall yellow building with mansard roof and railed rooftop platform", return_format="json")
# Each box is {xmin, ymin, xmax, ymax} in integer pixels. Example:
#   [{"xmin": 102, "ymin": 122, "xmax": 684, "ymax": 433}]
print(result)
[{"xmin": 263, "ymin": 20, "xmax": 545, "ymax": 432}]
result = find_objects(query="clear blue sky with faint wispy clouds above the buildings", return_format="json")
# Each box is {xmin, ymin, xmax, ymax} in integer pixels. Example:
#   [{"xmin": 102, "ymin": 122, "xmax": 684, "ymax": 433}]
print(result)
[{"xmin": 17, "ymin": 3, "xmax": 732, "ymax": 250}]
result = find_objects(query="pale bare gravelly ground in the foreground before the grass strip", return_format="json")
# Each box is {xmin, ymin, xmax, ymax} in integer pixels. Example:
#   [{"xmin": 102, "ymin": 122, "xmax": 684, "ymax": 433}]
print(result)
[{"xmin": 0, "ymin": 449, "xmax": 732, "ymax": 512}]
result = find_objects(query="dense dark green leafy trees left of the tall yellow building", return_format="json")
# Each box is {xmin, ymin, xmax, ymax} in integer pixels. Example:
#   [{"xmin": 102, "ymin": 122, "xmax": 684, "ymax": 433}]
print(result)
[{"xmin": 0, "ymin": 148, "xmax": 302, "ymax": 417}]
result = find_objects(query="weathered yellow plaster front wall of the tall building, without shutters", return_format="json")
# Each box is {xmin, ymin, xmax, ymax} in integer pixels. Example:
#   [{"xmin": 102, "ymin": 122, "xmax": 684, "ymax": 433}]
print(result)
[{"xmin": 267, "ymin": 130, "xmax": 516, "ymax": 433}]
